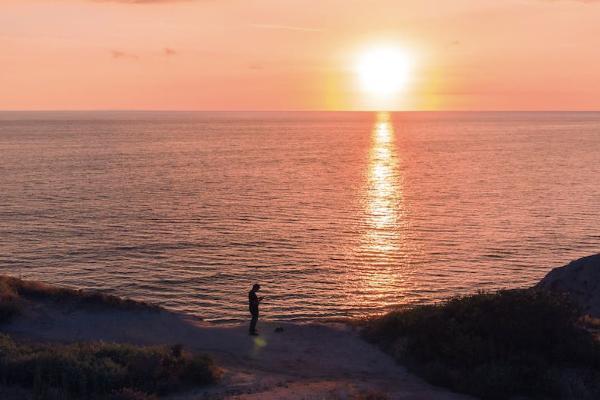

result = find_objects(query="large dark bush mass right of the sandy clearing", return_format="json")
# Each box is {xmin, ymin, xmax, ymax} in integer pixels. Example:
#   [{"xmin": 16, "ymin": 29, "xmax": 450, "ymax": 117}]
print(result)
[{"xmin": 364, "ymin": 290, "xmax": 600, "ymax": 400}]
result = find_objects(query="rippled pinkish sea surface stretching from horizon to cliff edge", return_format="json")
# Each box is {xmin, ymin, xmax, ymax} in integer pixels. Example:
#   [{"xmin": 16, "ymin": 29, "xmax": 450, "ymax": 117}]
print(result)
[{"xmin": 0, "ymin": 112, "xmax": 600, "ymax": 322}]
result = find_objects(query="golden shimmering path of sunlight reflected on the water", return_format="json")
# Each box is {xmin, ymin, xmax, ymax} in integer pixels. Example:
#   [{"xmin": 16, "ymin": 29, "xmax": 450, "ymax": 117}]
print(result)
[{"xmin": 362, "ymin": 112, "xmax": 403, "ymax": 294}]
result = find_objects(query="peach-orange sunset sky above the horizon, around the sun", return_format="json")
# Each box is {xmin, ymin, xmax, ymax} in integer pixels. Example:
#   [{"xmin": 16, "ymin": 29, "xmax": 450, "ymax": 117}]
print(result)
[{"xmin": 0, "ymin": 0, "xmax": 600, "ymax": 110}]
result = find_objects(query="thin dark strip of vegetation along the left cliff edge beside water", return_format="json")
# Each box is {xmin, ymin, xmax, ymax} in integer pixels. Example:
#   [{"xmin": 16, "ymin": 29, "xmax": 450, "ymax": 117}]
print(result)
[{"xmin": 0, "ymin": 276, "xmax": 159, "ymax": 323}]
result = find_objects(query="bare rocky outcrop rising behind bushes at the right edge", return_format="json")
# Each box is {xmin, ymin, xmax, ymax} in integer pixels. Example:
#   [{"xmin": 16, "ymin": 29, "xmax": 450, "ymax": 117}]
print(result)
[{"xmin": 536, "ymin": 254, "xmax": 600, "ymax": 318}]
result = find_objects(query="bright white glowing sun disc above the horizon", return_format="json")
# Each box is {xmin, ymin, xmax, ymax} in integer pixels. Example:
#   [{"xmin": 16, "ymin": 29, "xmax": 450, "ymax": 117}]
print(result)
[{"xmin": 356, "ymin": 47, "xmax": 411, "ymax": 97}]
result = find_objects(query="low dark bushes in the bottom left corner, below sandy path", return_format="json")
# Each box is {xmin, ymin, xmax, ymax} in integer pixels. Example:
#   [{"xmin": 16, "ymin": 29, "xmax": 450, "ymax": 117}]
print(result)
[{"xmin": 0, "ymin": 335, "xmax": 220, "ymax": 400}]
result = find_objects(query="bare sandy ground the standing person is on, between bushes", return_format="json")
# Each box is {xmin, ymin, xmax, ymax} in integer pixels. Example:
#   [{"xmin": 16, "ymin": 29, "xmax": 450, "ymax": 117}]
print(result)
[{"xmin": 2, "ymin": 303, "xmax": 467, "ymax": 400}]
